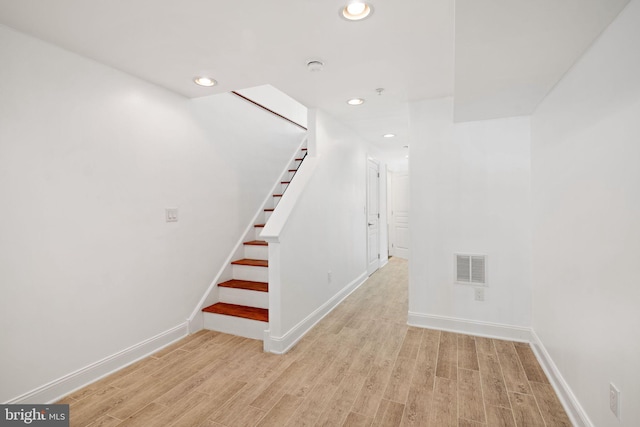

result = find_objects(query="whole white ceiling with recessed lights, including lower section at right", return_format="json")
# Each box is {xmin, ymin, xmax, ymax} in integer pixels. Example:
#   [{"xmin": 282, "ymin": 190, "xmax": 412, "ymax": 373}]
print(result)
[{"xmin": 0, "ymin": 0, "xmax": 628, "ymax": 164}]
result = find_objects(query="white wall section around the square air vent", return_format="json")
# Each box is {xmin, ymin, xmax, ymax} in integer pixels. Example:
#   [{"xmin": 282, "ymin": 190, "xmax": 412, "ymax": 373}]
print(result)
[{"xmin": 409, "ymin": 98, "xmax": 531, "ymax": 338}]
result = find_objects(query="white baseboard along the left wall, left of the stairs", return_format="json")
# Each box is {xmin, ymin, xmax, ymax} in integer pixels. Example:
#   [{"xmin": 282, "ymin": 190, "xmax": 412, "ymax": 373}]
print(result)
[{"xmin": 6, "ymin": 322, "xmax": 188, "ymax": 404}]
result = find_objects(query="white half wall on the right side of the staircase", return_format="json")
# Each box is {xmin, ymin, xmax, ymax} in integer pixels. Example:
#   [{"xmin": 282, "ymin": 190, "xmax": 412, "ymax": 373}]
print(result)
[{"xmin": 262, "ymin": 111, "xmax": 376, "ymax": 353}]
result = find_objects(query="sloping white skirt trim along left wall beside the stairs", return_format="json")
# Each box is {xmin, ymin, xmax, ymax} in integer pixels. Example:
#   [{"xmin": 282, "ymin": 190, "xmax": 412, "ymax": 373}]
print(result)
[{"xmin": 187, "ymin": 135, "xmax": 307, "ymax": 333}]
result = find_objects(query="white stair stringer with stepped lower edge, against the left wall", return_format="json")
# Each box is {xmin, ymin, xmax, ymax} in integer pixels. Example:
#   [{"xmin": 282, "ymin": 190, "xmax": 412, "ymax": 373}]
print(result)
[{"xmin": 187, "ymin": 135, "xmax": 307, "ymax": 334}]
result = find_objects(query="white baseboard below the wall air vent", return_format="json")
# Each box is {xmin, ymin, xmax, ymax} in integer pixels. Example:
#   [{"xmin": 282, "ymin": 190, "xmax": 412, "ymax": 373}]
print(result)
[{"xmin": 407, "ymin": 311, "xmax": 532, "ymax": 342}]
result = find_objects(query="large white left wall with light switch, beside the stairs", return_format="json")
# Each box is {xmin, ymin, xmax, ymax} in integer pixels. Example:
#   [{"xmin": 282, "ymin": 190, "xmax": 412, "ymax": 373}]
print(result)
[{"xmin": 0, "ymin": 26, "xmax": 301, "ymax": 402}]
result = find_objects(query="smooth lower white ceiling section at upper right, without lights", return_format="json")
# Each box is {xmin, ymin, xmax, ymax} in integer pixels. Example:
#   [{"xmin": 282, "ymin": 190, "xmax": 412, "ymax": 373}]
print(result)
[{"xmin": 454, "ymin": 0, "xmax": 629, "ymax": 121}]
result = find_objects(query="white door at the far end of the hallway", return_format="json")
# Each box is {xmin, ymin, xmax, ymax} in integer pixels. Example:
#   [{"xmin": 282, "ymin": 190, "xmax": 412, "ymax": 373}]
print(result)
[{"xmin": 389, "ymin": 172, "xmax": 409, "ymax": 259}]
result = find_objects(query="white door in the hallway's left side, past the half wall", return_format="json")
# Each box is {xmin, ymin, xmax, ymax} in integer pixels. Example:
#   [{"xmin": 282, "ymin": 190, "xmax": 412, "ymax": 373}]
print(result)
[{"xmin": 367, "ymin": 159, "xmax": 380, "ymax": 275}]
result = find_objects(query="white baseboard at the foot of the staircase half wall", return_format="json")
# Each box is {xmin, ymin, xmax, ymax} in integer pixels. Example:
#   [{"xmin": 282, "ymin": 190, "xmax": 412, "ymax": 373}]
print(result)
[{"xmin": 264, "ymin": 271, "xmax": 369, "ymax": 354}]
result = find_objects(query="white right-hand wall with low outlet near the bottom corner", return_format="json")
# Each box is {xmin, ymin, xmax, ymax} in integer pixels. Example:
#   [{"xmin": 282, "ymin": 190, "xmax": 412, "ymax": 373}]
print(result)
[{"xmin": 532, "ymin": 0, "xmax": 640, "ymax": 426}]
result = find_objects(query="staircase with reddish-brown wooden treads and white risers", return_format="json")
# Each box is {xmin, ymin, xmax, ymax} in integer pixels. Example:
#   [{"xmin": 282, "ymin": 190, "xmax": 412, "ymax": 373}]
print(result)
[{"xmin": 202, "ymin": 146, "xmax": 307, "ymax": 340}]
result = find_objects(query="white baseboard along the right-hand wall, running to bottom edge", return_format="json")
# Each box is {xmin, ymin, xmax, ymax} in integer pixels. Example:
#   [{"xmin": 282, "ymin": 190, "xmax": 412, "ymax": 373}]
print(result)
[{"xmin": 531, "ymin": 330, "xmax": 594, "ymax": 427}]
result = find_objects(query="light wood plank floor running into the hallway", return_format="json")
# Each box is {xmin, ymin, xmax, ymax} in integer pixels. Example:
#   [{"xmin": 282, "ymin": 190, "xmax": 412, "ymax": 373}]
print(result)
[{"xmin": 62, "ymin": 259, "xmax": 571, "ymax": 427}]
